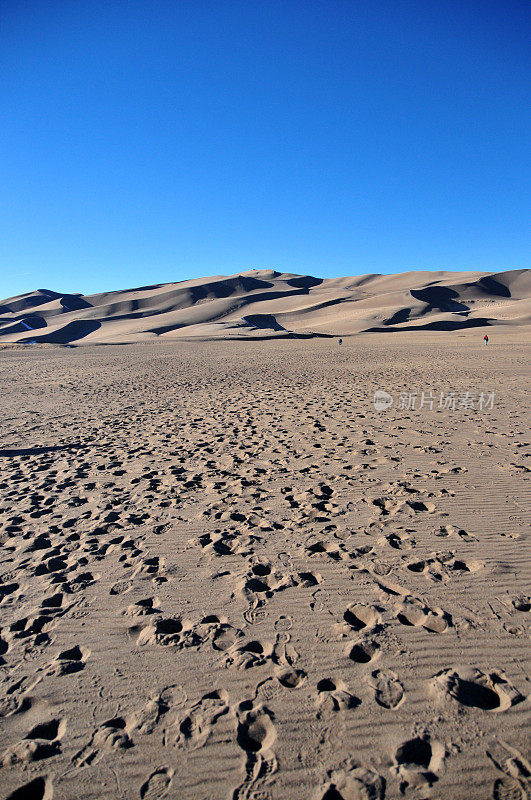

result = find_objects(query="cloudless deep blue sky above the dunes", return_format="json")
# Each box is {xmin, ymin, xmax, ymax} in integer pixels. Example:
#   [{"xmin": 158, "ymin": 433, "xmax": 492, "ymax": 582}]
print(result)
[{"xmin": 0, "ymin": 0, "xmax": 531, "ymax": 297}]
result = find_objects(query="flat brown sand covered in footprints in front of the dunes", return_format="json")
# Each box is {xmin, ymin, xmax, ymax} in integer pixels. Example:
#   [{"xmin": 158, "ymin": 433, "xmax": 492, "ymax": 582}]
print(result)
[{"xmin": 0, "ymin": 325, "xmax": 531, "ymax": 800}]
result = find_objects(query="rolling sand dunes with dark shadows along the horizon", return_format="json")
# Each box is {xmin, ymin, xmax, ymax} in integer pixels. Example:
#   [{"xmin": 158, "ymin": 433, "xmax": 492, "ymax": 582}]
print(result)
[{"xmin": 0, "ymin": 270, "xmax": 531, "ymax": 344}]
